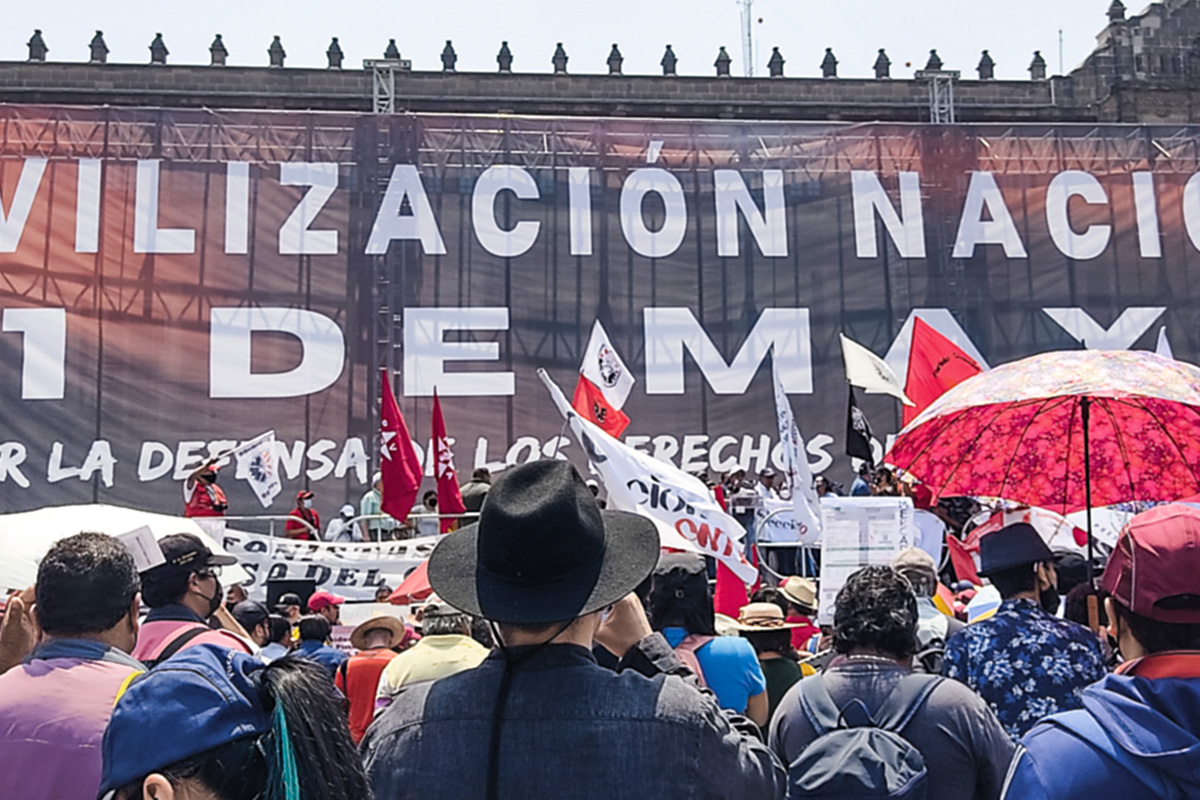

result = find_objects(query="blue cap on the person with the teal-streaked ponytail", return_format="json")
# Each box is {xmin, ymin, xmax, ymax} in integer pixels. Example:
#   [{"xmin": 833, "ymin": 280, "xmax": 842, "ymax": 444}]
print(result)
[{"xmin": 100, "ymin": 644, "xmax": 271, "ymax": 800}]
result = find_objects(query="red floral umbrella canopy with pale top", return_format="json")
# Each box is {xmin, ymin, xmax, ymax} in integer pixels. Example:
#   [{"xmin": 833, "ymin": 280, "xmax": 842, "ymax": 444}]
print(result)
[{"xmin": 884, "ymin": 350, "xmax": 1200, "ymax": 513}]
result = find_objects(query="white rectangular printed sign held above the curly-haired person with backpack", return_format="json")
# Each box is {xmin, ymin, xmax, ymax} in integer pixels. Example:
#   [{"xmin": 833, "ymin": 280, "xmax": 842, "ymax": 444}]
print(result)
[{"xmin": 817, "ymin": 495, "xmax": 913, "ymax": 625}]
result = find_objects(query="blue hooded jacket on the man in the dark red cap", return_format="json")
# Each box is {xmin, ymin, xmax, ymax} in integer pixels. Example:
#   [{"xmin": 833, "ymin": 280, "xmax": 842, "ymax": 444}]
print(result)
[{"xmin": 1002, "ymin": 662, "xmax": 1200, "ymax": 800}]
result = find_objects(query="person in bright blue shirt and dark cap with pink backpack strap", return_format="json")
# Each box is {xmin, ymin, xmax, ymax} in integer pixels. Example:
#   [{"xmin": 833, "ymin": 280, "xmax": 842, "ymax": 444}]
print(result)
[{"xmin": 649, "ymin": 553, "xmax": 769, "ymax": 727}]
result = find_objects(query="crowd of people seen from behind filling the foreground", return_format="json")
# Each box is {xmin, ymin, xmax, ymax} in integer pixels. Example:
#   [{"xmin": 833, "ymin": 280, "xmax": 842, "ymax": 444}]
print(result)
[{"xmin": 0, "ymin": 461, "xmax": 1200, "ymax": 800}]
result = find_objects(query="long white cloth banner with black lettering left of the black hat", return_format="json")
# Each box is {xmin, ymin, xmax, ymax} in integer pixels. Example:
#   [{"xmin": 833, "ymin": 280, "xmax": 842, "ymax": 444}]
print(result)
[{"xmin": 220, "ymin": 529, "xmax": 438, "ymax": 601}]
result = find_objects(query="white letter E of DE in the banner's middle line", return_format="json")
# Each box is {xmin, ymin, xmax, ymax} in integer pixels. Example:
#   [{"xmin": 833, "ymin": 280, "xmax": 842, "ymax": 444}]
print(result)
[{"xmin": 404, "ymin": 306, "xmax": 516, "ymax": 397}]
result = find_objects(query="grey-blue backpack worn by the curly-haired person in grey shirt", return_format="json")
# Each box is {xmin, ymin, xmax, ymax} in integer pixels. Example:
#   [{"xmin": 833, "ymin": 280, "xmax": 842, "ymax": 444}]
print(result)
[{"xmin": 787, "ymin": 675, "xmax": 943, "ymax": 800}]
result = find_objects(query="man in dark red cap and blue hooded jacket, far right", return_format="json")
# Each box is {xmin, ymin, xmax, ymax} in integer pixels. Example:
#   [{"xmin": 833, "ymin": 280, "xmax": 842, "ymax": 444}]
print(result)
[{"xmin": 1004, "ymin": 505, "xmax": 1200, "ymax": 800}]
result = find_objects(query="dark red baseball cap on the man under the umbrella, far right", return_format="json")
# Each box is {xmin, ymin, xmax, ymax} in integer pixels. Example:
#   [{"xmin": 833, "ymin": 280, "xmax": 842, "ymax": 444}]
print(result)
[{"xmin": 1100, "ymin": 504, "xmax": 1200, "ymax": 625}]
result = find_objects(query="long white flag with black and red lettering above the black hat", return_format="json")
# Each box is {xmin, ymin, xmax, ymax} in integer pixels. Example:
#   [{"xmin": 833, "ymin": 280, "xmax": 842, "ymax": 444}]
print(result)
[{"xmin": 538, "ymin": 369, "xmax": 758, "ymax": 585}]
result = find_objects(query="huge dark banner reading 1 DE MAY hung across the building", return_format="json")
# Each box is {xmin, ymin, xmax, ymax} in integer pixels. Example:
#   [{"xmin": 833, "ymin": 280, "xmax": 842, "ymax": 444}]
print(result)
[{"xmin": 0, "ymin": 106, "xmax": 1200, "ymax": 516}]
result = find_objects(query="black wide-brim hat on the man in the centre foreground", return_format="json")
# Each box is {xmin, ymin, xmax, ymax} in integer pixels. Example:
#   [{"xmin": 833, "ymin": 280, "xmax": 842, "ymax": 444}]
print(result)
[{"xmin": 428, "ymin": 461, "xmax": 659, "ymax": 625}]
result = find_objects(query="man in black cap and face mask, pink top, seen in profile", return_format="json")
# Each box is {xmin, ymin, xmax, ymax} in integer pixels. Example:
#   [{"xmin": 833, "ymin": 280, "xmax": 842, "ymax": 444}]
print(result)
[{"xmin": 133, "ymin": 534, "xmax": 251, "ymax": 663}]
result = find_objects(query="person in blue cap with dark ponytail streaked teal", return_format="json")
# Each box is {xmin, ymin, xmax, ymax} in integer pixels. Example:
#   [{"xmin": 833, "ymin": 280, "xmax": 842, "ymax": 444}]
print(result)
[{"xmin": 100, "ymin": 644, "xmax": 371, "ymax": 800}]
